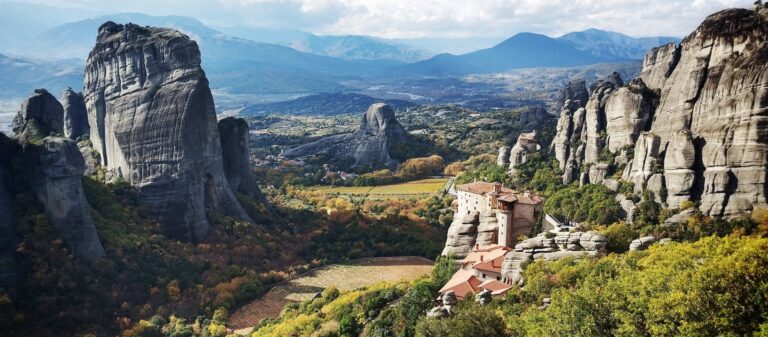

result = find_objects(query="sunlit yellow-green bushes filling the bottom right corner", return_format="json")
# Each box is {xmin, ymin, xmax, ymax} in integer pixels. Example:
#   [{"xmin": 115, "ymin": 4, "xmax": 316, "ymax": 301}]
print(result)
[{"xmin": 417, "ymin": 236, "xmax": 768, "ymax": 336}]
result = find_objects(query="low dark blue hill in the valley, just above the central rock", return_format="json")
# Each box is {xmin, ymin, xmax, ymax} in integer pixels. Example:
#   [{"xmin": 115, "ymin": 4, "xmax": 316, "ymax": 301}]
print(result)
[{"xmin": 240, "ymin": 93, "xmax": 417, "ymax": 115}]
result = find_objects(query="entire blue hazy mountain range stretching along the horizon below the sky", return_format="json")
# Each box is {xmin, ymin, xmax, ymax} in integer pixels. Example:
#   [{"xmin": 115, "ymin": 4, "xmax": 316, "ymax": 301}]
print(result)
[{"xmin": 0, "ymin": 5, "xmax": 670, "ymax": 98}]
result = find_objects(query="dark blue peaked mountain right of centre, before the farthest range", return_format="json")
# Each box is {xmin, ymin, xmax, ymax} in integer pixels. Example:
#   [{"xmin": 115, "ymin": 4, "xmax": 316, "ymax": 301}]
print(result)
[{"xmin": 404, "ymin": 33, "xmax": 622, "ymax": 75}]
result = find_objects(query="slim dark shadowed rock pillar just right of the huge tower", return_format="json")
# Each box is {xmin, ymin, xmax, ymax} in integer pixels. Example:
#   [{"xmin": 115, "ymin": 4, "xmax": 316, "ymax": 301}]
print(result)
[{"xmin": 219, "ymin": 117, "xmax": 267, "ymax": 203}]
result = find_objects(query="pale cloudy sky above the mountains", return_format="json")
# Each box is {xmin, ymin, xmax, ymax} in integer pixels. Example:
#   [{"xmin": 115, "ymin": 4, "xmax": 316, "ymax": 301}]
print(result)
[{"xmin": 0, "ymin": 0, "xmax": 753, "ymax": 38}]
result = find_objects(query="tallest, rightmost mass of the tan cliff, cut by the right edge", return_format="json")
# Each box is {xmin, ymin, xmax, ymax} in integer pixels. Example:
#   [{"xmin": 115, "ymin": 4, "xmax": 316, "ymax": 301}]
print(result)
[{"xmin": 628, "ymin": 9, "xmax": 768, "ymax": 217}]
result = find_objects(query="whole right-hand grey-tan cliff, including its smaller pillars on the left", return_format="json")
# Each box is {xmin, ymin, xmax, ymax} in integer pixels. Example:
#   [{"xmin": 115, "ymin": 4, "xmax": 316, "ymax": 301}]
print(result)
[{"xmin": 552, "ymin": 8, "xmax": 768, "ymax": 217}]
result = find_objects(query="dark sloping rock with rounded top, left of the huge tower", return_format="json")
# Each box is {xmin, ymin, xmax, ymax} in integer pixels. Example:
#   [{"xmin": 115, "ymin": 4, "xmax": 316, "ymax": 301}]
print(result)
[{"xmin": 14, "ymin": 90, "xmax": 104, "ymax": 259}]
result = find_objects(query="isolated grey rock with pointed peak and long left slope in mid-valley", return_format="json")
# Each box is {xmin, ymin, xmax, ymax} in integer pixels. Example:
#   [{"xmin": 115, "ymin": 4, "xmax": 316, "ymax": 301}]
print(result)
[{"xmin": 283, "ymin": 103, "xmax": 408, "ymax": 168}]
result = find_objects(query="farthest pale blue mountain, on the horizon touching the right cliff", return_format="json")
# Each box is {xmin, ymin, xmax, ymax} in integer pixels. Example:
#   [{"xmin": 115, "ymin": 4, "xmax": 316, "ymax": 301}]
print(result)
[{"xmin": 558, "ymin": 28, "xmax": 680, "ymax": 60}]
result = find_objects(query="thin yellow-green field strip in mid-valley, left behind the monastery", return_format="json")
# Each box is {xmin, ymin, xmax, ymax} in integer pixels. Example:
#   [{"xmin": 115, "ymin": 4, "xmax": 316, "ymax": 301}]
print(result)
[{"xmin": 313, "ymin": 178, "xmax": 449, "ymax": 196}]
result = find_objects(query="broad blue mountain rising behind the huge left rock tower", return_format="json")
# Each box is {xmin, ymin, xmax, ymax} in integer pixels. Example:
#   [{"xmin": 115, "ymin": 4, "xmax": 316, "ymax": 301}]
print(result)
[{"xmin": 17, "ymin": 13, "xmax": 397, "ymax": 93}]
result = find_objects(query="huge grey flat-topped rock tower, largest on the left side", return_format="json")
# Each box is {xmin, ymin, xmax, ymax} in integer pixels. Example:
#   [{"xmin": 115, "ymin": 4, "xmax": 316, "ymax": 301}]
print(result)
[{"xmin": 84, "ymin": 22, "xmax": 249, "ymax": 240}]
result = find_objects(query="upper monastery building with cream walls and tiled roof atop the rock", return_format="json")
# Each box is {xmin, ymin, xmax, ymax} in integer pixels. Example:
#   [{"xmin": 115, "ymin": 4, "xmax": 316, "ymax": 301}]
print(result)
[{"xmin": 454, "ymin": 182, "xmax": 542, "ymax": 247}]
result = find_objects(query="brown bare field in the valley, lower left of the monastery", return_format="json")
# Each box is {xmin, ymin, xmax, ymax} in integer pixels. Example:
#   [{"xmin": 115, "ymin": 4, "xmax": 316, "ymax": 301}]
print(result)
[{"xmin": 229, "ymin": 256, "xmax": 433, "ymax": 333}]
